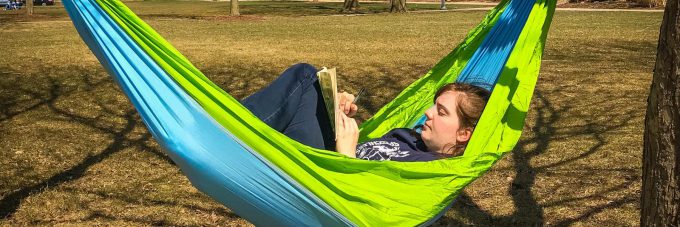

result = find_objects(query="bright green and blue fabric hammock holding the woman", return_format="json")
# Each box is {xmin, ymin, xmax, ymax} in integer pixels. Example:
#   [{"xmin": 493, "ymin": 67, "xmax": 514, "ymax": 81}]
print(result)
[{"xmin": 63, "ymin": 0, "xmax": 556, "ymax": 226}]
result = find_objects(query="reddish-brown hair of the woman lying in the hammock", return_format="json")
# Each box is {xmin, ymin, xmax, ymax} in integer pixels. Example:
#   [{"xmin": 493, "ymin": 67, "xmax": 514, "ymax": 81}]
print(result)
[{"xmin": 434, "ymin": 83, "xmax": 491, "ymax": 157}]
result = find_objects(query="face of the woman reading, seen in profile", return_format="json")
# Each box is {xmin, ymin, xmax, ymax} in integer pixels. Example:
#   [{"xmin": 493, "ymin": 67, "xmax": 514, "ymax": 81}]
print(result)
[{"xmin": 421, "ymin": 91, "xmax": 472, "ymax": 153}]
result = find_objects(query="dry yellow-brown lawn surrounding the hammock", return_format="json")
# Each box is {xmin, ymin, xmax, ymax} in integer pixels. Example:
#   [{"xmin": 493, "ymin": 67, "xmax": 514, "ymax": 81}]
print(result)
[{"xmin": 0, "ymin": 2, "xmax": 662, "ymax": 226}]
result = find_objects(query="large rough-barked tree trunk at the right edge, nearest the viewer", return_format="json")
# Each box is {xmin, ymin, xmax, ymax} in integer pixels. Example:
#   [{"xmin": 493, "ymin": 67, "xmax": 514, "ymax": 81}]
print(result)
[{"xmin": 640, "ymin": 0, "xmax": 680, "ymax": 226}]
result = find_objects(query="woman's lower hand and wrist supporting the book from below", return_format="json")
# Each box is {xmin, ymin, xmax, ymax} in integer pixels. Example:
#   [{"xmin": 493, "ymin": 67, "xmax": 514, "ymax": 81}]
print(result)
[{"xmin": 335, "ymin": 111, "xmax": 359, "ymax": 158}]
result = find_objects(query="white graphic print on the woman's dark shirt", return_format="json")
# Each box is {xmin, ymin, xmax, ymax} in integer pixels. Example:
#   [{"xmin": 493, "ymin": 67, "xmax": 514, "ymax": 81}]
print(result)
[{"xmin": 357, "ymin": 141, "xmax": 409, "ymax": 161}]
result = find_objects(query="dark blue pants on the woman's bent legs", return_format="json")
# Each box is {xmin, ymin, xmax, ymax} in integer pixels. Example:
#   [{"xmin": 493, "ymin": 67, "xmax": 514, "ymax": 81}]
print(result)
[{"xmin": 241, "ymin": 63, "xmax": 335, "ymax": 150}]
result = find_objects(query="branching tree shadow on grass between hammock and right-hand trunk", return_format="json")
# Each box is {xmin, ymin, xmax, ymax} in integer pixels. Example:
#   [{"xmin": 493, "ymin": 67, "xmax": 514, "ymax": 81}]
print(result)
[{"xmin": 434, "ymin": 86, "xmax": 640, "ymax": 226}]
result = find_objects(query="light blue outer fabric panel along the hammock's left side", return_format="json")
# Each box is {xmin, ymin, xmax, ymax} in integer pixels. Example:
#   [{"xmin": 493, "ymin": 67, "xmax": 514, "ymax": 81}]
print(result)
[{"xmin": 64, "ymin": 1, "xmax": 352, "ymax": 226}]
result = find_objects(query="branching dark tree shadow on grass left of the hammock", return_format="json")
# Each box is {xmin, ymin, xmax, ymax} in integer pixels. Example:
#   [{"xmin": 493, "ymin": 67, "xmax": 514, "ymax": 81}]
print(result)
[{"xmin": 0, "ymin": 66, "xmax": 178, "ymax": 218}]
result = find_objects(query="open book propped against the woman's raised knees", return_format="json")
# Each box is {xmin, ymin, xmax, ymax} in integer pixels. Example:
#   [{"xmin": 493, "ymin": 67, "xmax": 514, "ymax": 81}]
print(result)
[{"xmin": 316, "ymin": 67, "xmax": 339, "ymax": 138}]
